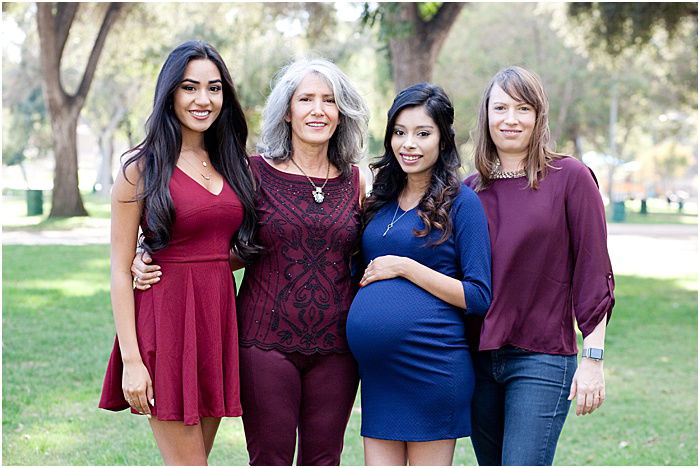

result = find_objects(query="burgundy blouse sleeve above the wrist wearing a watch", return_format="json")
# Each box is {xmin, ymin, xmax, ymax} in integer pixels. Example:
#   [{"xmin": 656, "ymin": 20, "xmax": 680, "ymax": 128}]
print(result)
[{"xmin": 566, "ymin": 164, "xmax": 615, "ymax": 338}]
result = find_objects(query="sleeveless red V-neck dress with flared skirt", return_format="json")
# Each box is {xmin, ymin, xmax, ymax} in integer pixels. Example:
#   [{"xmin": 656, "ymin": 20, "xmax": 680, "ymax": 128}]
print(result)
[{"xmin": 99, "ymin": 167, "xmax": 243, "ymax": 426}]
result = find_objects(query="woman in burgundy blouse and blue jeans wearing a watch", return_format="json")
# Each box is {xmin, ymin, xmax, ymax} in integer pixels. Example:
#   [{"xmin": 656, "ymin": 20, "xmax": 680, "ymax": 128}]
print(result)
[{"xmin": 465, "ymin": 67, "xmax": 615, "ymax": 465}]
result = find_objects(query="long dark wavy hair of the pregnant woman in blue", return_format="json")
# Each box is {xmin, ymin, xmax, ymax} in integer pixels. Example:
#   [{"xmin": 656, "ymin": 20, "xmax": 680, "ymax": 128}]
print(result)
[{"xmin": 364, "ymin": 83, "xmax": 462, "ymax": 245}]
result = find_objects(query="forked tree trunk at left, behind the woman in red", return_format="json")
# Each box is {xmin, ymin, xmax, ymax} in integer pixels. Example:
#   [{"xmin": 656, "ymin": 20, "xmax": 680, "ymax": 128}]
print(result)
[{"xmin": 37, "ymin": 3, "xmax": 121, "ymax": 218}]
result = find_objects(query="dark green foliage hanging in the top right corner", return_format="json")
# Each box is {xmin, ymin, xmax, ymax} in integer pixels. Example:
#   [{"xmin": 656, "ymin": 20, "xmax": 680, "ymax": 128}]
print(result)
[{"xmin": 569, "ymin": 2, "xmax": 698, "ymax": 55}]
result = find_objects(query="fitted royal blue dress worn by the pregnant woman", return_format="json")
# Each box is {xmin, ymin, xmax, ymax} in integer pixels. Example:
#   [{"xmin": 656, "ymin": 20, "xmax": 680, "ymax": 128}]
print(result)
[{"xmin": 347, "ymin": 186, "xmax": 491, "ymax": 442}]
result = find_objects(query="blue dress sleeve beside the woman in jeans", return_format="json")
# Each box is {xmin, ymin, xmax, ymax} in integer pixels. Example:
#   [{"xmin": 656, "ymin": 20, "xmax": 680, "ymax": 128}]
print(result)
[{"xmin": 452, "ymin": 186, "xmax": 491, "ymax": 317}]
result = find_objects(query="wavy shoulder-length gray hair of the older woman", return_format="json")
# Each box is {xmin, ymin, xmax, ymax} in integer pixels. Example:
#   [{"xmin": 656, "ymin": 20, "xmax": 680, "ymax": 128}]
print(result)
[{"xmin": 258, "ymin": 58, "xmax": 369, "ymax": 176}]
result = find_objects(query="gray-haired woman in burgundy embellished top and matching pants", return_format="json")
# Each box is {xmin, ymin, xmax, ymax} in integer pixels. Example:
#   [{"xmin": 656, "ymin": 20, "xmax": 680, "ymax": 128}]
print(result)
[{"xmin": 134, "ymin": 59, "xmax": 369, "ymax": 465}]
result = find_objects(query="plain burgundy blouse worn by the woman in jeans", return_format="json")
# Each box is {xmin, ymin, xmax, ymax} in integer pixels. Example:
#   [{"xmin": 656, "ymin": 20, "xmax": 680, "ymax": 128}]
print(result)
[{"xmin": 464, "ymin": 158, "xmax": 615, "ymax": 355}]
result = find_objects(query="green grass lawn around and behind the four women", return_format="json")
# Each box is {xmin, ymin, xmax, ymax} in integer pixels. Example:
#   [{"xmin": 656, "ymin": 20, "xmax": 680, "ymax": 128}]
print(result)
[{"xmin": 2, "ymin": 245, "xmax": 698, "ymax": 465}]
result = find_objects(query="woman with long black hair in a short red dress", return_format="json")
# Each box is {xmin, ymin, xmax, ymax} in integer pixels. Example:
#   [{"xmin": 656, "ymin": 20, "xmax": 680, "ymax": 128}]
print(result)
[{"xmin": 99, "ymin": 41, "xmax": 257, "ymax": 465}]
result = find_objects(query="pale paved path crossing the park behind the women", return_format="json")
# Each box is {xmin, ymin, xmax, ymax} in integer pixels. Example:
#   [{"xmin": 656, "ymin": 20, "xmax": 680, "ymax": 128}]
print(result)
[{"xmin": 2, "ymin": 223, "xmax": 699, "ymax": 277}]
